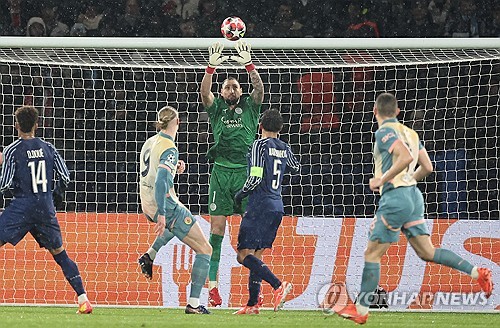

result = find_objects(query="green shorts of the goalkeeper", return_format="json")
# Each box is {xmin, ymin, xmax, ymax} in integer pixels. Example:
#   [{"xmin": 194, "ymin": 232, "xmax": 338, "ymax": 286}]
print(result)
[{"xmin": 208, "ymin": 164, "xmax": 248, "ymax": 216}]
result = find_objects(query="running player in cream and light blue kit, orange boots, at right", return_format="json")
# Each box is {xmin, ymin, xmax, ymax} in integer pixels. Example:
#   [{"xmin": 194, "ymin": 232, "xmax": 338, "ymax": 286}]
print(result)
[{"xmin": 337, "ymin": 93, "xmax": 493, "ymax": 324}]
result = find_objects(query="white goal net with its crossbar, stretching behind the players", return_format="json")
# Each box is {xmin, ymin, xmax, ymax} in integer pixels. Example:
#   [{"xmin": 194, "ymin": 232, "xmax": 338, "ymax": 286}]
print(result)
[{"xmin": 0, "ymin": 38, "xmax": 500, "ymax": 310}]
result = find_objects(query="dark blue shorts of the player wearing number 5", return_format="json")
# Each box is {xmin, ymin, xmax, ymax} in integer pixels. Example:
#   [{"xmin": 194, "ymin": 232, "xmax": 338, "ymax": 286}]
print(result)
[{"xmin": 237, "ymin": 211, "xmax": 283, "ymax": 249}]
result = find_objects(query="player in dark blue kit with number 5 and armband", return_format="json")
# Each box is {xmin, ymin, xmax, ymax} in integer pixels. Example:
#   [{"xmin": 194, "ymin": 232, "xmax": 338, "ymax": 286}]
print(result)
[{"xmin": 235, "ymin": 109, "xmax": 300, "ymax": 314}]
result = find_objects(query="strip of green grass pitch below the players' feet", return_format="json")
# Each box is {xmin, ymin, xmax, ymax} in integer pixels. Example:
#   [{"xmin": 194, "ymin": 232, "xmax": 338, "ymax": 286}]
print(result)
[{"xmin": 0, "ymin": 306, "xmax": 500, "ymax": 328}]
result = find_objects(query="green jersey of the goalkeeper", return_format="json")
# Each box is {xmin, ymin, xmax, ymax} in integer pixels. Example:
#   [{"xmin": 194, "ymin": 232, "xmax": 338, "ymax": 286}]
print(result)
[{"xmin": 206, "ymin": 96, "xmax": 260, "ymax": 168}]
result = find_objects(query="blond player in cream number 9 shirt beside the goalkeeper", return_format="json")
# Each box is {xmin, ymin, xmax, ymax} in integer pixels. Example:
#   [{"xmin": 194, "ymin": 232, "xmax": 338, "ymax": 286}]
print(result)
[{"xmin": 141, "ymin": 106, "xmax": 212, "ymax": 314}]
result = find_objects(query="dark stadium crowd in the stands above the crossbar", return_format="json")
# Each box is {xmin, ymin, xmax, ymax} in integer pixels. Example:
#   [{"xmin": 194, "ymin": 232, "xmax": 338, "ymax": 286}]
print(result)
[{"xmin": 0, "ymin": 0, "xmax": 500, "ymax": 38}]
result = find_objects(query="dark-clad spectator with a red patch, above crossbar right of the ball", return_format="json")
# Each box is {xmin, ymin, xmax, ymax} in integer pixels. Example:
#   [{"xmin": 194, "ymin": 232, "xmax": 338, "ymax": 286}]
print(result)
[{"xmin": 345, "ymin": 1, "xmax": 380, "ymax": 38}]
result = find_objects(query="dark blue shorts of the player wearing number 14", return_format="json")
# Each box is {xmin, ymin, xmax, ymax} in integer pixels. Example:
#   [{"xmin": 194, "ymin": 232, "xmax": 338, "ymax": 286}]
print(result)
[{"xmin": 0, "ymin": 198, "xmax": 62, "ymax": 249}]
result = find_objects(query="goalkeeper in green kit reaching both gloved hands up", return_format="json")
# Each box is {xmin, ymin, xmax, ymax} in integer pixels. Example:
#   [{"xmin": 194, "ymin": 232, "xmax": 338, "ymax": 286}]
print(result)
[{"xmin": 200, "ymin": 41, "xmax": 264, "ymax": 306}]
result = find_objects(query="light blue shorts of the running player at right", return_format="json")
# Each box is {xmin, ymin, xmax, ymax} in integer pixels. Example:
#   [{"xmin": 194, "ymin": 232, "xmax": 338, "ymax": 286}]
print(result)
[{"xmin": 369, "ymin": 186, "xmax": 429, "ymax": 243}]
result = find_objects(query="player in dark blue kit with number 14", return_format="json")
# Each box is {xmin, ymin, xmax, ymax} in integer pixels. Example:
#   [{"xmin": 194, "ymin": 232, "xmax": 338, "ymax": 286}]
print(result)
[{"xmin": 0, "ymin": 106, "xmax": 92, "ymax": 314}]
